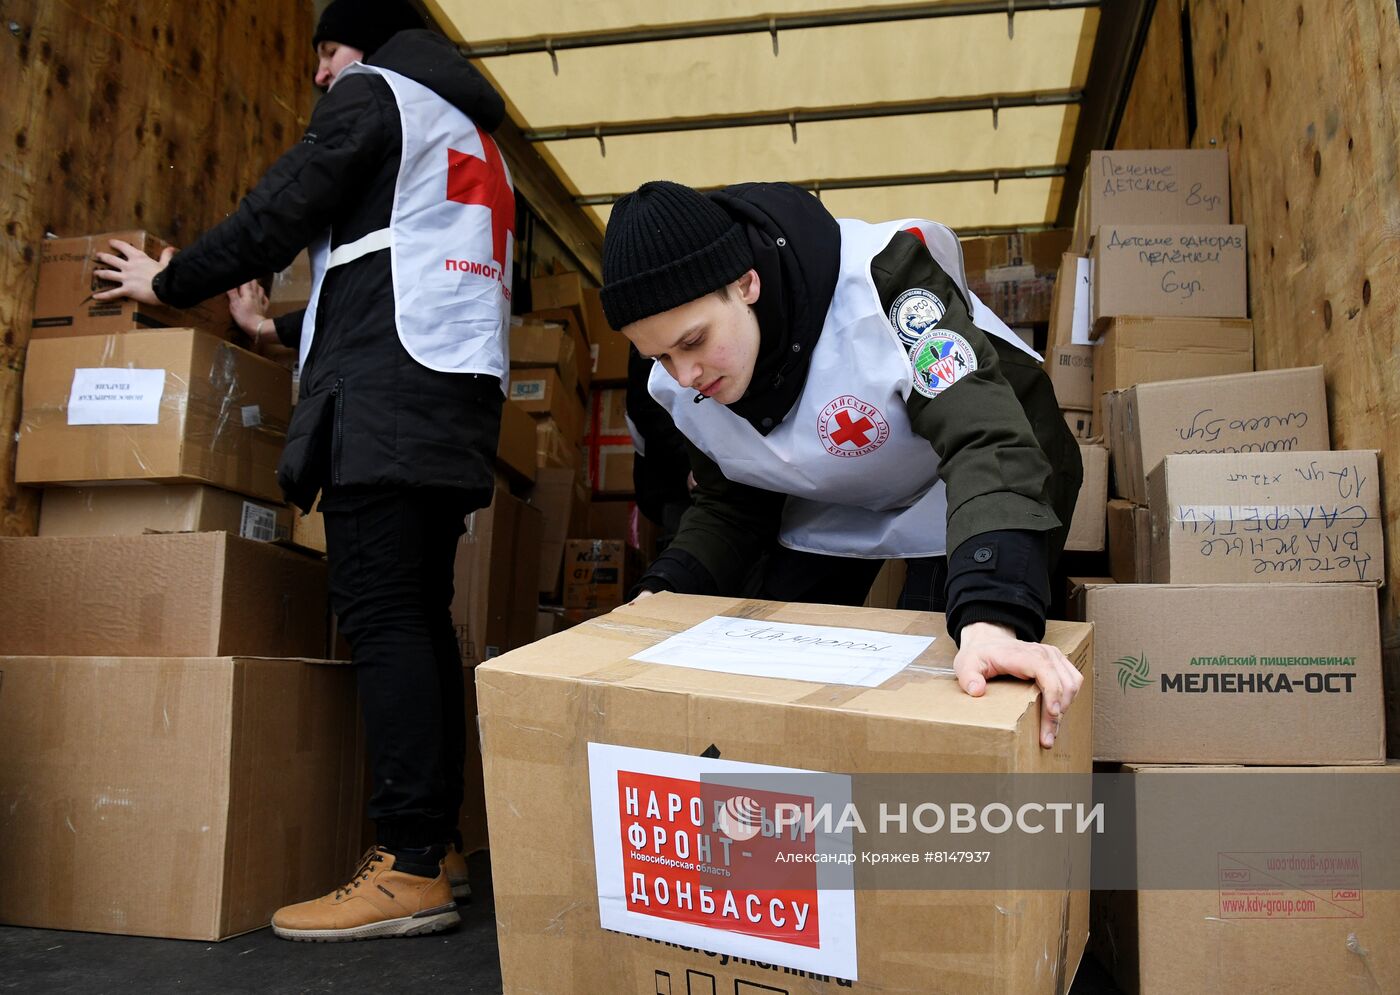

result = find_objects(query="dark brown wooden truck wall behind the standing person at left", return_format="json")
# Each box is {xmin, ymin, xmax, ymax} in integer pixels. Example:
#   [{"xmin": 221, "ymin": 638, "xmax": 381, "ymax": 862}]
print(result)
[{"xmin": 0, "ymin": 0, "xmax": 315, "ymax": 535}]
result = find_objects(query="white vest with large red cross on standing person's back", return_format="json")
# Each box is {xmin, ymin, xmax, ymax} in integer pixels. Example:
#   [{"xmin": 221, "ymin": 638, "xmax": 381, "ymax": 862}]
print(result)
[{"xmin": 301, "ymin": 63, "xmax": 515, "ymax": 389}]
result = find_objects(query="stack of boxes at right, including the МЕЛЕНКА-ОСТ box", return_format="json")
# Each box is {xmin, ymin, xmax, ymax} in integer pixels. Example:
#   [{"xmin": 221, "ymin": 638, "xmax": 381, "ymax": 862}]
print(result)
[{"xmin": 1050, "ymin": 159, "xmax": 1400, "ymax": 991}]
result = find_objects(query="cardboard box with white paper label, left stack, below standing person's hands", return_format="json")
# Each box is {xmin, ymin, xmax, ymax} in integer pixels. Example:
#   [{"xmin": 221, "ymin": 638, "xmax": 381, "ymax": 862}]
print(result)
[{"xmin": 15, "ymin": 329, "xmax": 291, "ymax": 502}]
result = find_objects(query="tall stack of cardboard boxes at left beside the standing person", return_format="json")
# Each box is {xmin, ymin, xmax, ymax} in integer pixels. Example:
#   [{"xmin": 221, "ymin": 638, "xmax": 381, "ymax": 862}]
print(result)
[{"xmin": 0, "ymin": 232, "xmax": 364, "ymax": 939}]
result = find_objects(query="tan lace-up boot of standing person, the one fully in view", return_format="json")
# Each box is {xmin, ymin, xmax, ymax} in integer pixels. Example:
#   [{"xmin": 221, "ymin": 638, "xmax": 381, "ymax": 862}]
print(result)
[{"xmin": 272, "ymin": 847, "xmax": 461, "ymax": 943}]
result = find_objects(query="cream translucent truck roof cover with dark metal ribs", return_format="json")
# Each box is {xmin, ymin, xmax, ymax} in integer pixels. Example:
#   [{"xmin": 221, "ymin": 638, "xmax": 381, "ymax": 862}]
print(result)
[{"xmin": 427, "ymin": 0, "xmax": 1103, "ymax": 230}]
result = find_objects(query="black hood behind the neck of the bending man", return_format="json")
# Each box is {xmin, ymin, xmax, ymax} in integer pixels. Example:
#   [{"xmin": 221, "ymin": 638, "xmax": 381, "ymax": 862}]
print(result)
[{"xmin": 710, "ymin": 183, "xmax": 841, "ymax": 435}]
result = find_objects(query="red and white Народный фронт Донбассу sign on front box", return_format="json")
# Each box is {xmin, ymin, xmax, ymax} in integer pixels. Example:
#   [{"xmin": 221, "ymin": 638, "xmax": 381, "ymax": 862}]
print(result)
[{"xmin": 588, "ymin": 743, "xmax": 857, "ymax": 981}]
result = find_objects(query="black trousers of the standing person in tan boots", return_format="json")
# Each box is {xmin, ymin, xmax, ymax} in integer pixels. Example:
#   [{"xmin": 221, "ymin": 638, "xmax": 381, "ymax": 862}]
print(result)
[{"xmin": 321, "ymin": 487, "xmax": 475, "ymax": 848}]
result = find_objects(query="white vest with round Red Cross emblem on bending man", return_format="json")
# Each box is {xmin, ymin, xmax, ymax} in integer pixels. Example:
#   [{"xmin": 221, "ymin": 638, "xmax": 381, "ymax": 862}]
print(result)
[{"xmin": 648, "ymin": 218, "xmax": 1039, "ymax": 558}]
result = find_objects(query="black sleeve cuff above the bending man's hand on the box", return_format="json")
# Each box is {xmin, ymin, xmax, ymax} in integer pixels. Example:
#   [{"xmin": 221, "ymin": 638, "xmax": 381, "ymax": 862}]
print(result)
[{"xmin": 948, "ymin": 529, "xmax": 1050, "ymax": 645}]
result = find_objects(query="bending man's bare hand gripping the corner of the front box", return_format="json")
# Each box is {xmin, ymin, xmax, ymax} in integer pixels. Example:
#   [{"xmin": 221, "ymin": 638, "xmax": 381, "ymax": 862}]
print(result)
[{"xmin": 953, "ymin": 621, "xmax": 1084, "ymax": 749}]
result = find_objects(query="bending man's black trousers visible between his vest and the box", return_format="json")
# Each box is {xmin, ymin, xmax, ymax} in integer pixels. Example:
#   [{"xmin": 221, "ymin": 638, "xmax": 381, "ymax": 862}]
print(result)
[{"xmin": 745, "ymin": 546, "xmax": 948, "ymax": 612}]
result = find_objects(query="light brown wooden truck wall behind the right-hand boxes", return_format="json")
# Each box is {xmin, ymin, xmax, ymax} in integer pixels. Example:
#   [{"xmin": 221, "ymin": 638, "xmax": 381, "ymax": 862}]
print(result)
[{"xmin": 1117, "ymin": 0, "xmax": 1400, "ymax": 757}]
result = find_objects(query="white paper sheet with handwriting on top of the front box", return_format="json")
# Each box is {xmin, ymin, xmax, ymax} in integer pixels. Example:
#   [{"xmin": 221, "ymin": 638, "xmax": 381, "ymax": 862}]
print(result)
[{"xmin": 633, "ymin": 614, "xmax": 935, "ymax": 687}]
